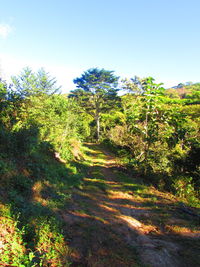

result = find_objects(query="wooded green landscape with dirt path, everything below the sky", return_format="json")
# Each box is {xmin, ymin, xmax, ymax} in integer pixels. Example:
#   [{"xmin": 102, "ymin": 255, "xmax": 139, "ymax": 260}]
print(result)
[{"xmin": 0, "ymin": 68, "xmax": 200, "ymax": 267}]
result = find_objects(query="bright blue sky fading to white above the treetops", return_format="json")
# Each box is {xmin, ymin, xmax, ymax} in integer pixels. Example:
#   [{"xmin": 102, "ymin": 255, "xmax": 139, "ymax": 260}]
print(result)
[{"xmin": 0, "ymin": 0, "xmax": 200, "ymax": 93}]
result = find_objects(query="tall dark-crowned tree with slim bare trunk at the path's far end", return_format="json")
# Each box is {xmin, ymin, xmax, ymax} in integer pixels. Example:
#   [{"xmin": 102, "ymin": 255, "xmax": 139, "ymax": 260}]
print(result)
[{"xmin": 69, "ymin": 68, "xmax": 119, "ymax": 141}]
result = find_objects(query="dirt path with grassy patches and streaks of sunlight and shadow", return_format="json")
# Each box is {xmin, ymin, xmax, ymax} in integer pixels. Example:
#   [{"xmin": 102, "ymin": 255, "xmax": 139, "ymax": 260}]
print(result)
[{"xmin": 62, "ymin": 144, "xmax": 200, "ymax": 267}]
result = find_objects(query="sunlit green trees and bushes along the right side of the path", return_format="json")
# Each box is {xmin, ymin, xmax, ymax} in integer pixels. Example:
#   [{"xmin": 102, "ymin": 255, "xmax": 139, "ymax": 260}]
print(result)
[{"xmin": 107, "ymin": 78, "xmax": 200, "ymax": 204}]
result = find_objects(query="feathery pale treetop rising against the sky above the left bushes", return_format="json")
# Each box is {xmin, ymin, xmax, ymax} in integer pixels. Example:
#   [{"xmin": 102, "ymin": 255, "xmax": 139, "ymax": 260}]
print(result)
[{"xmin": 12, "ymin": 67, "xmax": 60, "ymax": 98}]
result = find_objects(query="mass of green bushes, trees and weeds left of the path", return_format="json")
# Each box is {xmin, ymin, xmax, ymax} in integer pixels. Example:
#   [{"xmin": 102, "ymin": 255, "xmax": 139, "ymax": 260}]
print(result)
[{"xmin": 0, "ymin": 69, "xmax": 90, "ymax": 267}]
